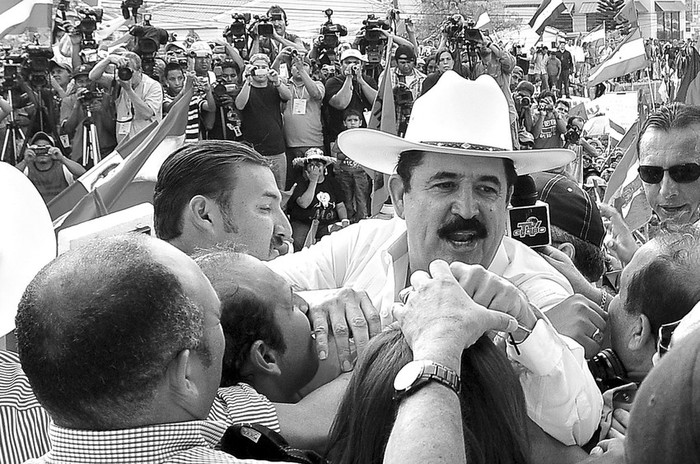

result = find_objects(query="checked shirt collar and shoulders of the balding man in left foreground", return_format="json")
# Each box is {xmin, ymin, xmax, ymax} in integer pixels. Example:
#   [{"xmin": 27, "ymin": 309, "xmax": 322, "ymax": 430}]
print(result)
[{"xmin": 23, "ymin": 420, "xmax": 288, "ymax": 464}]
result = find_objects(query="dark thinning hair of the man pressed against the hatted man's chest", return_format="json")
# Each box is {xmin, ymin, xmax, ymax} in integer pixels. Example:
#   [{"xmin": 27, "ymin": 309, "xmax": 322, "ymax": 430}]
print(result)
[{"xmin": 195, "ymin": 250, "xmax": 287, "ymax": 387}]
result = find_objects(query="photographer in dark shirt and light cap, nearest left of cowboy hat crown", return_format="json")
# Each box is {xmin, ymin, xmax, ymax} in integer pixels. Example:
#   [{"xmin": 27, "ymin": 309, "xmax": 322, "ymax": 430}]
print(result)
[{"xmin": 325, "ymin": 48, "xmax": 377, "ymax": 141}]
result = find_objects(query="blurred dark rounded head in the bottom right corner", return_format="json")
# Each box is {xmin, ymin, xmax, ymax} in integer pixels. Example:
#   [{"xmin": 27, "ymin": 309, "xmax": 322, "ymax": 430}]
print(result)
[{"xmin": 625, "ymin": 330, "xmax": 700, "ymax": 464}]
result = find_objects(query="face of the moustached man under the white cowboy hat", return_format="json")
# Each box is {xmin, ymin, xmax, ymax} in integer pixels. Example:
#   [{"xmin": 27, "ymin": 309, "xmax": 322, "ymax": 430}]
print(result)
[{"xmin": 392, "ymin": 153, "xmax": 510, "ymax": 270}]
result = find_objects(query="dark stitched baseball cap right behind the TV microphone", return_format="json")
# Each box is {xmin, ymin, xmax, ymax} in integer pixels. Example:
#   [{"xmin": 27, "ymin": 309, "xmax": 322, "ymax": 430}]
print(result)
[{"xmin": 532, "ymin": 172, "xmax": 605, "ymax": 247}]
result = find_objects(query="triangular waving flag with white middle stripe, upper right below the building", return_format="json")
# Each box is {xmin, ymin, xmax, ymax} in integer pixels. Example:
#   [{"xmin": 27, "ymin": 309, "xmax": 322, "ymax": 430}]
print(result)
[{"xmin": 588, "ymin": 29, "xmax": 647, "ymax": 87}]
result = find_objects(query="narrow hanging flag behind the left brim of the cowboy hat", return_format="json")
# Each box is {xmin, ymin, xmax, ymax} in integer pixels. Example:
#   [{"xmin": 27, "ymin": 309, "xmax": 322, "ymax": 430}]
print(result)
[{"xmin": 367, "ymin": 37, "xmax": 398, "ymax": 216}]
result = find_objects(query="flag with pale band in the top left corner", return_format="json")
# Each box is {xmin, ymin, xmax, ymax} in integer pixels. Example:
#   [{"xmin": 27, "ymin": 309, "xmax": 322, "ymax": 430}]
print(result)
[{"xmin": 0, "ymin": 0, "xmax": 53, "ymax": 38}]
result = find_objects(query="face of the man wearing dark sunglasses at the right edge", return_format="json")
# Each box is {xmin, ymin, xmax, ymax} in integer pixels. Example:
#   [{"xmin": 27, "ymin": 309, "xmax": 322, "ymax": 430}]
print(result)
[{"xmin": 639, "ymin": 124, "xmax": 700, "ymax": 224}]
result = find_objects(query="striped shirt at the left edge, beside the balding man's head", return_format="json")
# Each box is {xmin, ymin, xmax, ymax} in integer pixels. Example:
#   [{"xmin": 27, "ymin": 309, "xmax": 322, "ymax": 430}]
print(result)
[{"xmin": 0, "ymin": 350, "xmax": 50, "ymax": 464}]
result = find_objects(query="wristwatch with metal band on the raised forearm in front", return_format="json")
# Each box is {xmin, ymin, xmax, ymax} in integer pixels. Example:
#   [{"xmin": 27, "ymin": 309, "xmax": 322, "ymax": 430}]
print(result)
[{"xmin": 394, "ymin": 360, "xmax": 462, "ymax": 400}]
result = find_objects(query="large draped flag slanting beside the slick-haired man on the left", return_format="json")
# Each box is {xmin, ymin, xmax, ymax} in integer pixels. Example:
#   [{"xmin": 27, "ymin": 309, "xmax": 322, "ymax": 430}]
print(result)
[{"xmin": 54, "ymin": 88, "xmax": 192, "ymax": 233}]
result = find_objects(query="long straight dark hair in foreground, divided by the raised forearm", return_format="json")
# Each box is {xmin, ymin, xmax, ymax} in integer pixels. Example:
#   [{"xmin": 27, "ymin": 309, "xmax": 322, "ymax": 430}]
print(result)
[{"xmin": 328, "ymin": 330, "xmax": 529, "ymax": 464}]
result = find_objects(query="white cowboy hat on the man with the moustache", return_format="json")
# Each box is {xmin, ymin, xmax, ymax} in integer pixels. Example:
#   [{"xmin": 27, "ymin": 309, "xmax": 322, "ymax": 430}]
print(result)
[{"xmin": 338, "ymin": 71, "xmax": 575, "ymax": 176}]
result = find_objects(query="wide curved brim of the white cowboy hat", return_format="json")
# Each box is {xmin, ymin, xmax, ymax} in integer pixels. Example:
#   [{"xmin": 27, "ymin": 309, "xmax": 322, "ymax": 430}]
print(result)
[{"xmin": 338, "ymin": 129, "xmax": 576, "ymax": 176}]
